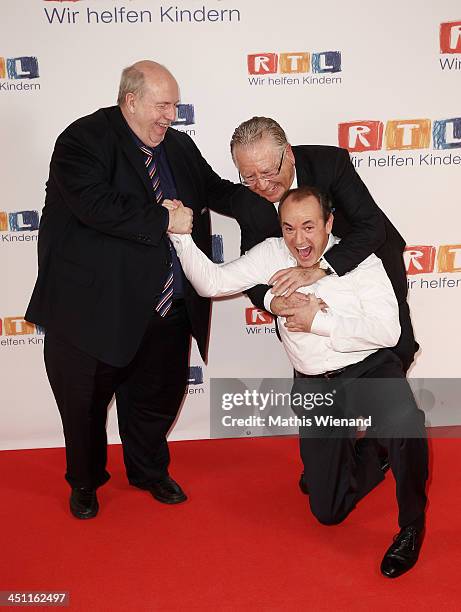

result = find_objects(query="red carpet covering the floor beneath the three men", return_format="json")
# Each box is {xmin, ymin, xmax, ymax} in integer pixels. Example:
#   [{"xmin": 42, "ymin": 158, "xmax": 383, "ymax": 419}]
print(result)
[{"xmin": 0, "ymin": 438, "xmax": 461, "ymax": 612}]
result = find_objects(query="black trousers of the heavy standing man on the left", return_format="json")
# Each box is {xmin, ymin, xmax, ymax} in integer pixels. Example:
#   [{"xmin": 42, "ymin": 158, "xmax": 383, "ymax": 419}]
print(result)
[{"xmin": 44, "ymin": 300, "xmax": 191, "ymax": 488}]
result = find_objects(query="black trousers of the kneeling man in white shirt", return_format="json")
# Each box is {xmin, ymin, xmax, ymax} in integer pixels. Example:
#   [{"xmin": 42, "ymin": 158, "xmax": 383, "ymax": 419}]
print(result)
[{"xmin": 293, "ymin": 349, "xmax": 428, "ymax": 528}]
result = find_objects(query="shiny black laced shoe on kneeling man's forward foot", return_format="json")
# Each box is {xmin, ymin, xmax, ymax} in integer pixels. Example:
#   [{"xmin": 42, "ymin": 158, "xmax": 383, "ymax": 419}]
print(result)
[{"xmin": 381, "ymin": 525, "xmax": 424, "ymax": 578}]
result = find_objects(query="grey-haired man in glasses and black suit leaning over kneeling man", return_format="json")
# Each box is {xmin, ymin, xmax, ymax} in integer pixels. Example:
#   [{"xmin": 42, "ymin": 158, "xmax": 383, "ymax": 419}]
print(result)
[{"xmin": 231, "ymin": 117, "xmax": 418, "ymax": 371}]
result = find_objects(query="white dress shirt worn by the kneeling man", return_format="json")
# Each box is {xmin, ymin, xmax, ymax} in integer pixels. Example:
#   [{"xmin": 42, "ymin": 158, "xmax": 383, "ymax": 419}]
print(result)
[{"xmin": 170, "ymin": 234, "xmax": 400, "ymax": 374}]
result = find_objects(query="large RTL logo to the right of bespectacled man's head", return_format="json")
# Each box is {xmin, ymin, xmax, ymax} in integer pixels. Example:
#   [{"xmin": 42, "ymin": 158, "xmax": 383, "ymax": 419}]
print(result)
[{"xmin": 338, "ymin": 117, "xmax": 461, "ymax": 153}]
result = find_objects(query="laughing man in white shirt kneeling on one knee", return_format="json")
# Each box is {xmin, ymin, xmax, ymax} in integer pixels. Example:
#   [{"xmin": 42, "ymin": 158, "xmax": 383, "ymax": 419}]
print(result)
[{"xmin": 171, "ymin": 186, "xmax": 427, "ymax": 578}]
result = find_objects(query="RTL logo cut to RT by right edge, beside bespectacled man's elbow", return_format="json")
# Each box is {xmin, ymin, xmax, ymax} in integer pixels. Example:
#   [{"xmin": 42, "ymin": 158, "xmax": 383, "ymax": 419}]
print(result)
[{"xmin": 403, "ymin": 244, "xmax": 461, "ymax": 275}]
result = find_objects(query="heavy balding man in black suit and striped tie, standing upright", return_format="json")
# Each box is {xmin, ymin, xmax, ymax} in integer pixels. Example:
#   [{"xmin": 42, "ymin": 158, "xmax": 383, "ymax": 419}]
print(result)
[{"xmin": 26, "ymin": 61, "xmax": 254, "ymax": 519}]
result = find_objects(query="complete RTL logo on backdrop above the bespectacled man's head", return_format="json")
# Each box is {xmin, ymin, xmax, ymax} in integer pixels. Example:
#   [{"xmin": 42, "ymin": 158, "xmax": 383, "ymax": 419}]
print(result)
[{"xmin": 247, "ymin": 51, "xmax": 341, "ymax": 76}]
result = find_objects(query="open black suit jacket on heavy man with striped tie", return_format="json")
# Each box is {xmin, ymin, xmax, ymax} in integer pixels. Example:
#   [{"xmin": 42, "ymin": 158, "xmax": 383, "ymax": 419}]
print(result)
[{"xmin": 26, "ymin": 107, "xmax": 248, "ymax": 366}]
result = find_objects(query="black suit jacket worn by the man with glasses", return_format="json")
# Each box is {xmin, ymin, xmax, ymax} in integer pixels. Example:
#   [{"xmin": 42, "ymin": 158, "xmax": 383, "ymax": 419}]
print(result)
[{"xmin": 233, "ymin": 145, "xmax": 407, "ymax": 308}]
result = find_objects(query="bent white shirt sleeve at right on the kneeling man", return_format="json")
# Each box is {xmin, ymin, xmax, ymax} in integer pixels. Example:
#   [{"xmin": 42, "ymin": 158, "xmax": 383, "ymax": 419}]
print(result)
[{"xmin": 326, "ymin": 255, "xmax": 400, "ymax": 352}]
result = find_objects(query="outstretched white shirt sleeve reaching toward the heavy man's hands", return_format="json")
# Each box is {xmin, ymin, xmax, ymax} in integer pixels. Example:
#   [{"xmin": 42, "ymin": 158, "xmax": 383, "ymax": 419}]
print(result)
[{"xmin": 170, "ymin": 234, "xmax": 278, "ymax": 297}]
